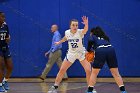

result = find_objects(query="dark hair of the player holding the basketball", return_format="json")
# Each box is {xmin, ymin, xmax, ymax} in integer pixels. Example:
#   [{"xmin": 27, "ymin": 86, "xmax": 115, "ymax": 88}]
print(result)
[{"xmin": 90, "ymin": 26, "xmax": 110, "ymax": 41}]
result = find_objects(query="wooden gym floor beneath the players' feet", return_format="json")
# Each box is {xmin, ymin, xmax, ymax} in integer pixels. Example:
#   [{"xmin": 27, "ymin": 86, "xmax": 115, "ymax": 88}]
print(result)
[{"xmin": 5, "ymin": 78, "xmax": 140, "ymax": 93}]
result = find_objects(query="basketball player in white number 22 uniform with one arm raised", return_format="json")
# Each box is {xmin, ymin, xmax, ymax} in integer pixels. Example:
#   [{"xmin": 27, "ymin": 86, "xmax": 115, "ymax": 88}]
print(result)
[{"xmin": 48, "ymin": 16, "xmax": 91, "ymax": 93}]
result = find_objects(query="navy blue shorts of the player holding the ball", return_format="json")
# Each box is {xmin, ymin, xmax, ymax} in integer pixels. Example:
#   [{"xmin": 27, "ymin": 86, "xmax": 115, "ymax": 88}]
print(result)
[{"xmin": 92, "ymin": 46, "xmax": 118, "ymax": 69}]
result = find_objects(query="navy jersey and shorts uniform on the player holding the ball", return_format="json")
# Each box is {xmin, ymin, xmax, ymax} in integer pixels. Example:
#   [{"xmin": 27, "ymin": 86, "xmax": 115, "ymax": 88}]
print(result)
[{"xmin": 87, "ymin": 35, "xmax": 118, "ymax": 69}]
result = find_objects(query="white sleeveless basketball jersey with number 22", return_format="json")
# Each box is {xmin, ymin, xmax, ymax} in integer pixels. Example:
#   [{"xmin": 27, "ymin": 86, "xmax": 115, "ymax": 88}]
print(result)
[{"xmin": 65, "ymin": 29, "xmax": 85, "ymax": 52}]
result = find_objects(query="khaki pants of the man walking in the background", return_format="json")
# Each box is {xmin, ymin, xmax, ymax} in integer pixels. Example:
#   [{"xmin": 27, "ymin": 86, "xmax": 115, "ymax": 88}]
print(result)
[{"xmin": 41, "ymin": 50, "xmax": 68, "ymax": 79}]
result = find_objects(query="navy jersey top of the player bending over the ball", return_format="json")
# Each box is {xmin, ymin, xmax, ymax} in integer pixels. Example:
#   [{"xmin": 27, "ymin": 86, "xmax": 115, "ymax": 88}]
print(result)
[{"xmin": 87, "ymin": 35, "xmax": 110, "ymax": 51}]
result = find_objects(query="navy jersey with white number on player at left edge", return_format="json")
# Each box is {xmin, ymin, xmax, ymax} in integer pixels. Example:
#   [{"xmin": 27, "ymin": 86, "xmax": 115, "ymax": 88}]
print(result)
[{"xmin": 0, "ymin": 22, "xmax": 9, "ymax": 47}]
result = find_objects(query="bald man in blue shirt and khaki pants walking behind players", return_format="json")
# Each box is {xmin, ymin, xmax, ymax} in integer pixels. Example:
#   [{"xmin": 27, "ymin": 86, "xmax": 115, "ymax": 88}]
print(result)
[{"xmin": 40, "ymin": 25, "xmax": 68, "ymax": 80}]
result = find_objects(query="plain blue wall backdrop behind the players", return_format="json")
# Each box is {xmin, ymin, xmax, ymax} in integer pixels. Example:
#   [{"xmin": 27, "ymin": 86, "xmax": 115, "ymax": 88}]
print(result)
[{"xmin": 0, "ymin": 0, "xmax": 140, "ymax": 77}]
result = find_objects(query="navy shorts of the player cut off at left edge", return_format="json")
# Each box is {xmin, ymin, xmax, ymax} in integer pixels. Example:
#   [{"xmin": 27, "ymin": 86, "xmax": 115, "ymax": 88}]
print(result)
[{"xmin": 0, "ymin": 46, "xmax": 11, "ymax": 58}]
